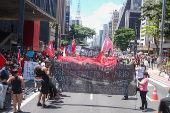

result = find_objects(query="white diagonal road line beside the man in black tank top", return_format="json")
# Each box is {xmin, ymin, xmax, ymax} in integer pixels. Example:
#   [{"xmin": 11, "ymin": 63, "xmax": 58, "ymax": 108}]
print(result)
[{"xmin": 8, "ymin": 92, "xmax": 39, "ymax": 113}]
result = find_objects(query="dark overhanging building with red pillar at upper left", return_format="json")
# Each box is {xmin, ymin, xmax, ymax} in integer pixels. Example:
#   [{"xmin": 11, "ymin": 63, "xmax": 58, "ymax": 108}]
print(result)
[{"xmin": 0, "ymin": 0, "xmax": 57, "ymax": 51}]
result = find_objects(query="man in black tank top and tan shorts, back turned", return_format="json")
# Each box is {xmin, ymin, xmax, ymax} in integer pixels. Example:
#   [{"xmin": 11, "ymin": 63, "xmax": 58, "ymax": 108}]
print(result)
[{"xmin": 7, "ymin": 69, "xmax": 25, "ymax": 113}]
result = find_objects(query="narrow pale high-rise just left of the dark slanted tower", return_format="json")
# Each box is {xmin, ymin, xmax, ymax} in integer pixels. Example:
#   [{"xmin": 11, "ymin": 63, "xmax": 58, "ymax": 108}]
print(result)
[{"xmin": 112, "ymin": 10, "xmax": 119, "ymax": 37}]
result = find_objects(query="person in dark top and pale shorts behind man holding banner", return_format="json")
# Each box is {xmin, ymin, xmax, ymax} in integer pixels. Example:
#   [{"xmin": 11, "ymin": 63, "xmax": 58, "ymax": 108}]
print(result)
[{"xmin": 34, "ymin": 61, "xmax": 42, "ymax": 92}]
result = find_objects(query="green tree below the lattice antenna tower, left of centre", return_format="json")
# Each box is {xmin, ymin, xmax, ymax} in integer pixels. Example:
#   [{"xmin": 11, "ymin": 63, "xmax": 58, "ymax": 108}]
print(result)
[{"xmin": 69, "ymin": 25, "xmax": 96, "ymax": 44}]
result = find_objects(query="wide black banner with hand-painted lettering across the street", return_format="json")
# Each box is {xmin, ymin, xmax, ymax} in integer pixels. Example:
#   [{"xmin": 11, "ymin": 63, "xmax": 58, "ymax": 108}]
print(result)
[{"xmin": 51, "ymin": 60, "xmax": 136, "ymax": 96}]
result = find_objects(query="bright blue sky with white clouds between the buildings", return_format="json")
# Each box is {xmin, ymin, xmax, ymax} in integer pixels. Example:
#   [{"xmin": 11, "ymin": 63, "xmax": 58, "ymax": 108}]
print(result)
[{"xmin": 71, "ymin": 0, "xmax": 126, "ymax": 42}]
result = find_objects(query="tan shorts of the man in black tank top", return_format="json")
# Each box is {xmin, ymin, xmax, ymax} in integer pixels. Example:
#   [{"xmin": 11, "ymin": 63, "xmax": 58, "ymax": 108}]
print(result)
[{"xmin": 11, "ymin": 93, "xmax": 22, "ymax": 104}]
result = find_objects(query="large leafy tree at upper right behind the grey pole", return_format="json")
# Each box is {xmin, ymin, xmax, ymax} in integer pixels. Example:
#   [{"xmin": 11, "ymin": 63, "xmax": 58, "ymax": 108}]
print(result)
[{"xmin": 141, "ymin": 0, "xmax": 170, "ymax": 54}]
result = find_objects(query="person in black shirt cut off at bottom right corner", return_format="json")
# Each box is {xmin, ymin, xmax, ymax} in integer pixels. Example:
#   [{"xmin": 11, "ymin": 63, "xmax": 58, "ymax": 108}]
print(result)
[{"xmin": 157, "ymin": 88, "xmax": 170, "ymax": 113}]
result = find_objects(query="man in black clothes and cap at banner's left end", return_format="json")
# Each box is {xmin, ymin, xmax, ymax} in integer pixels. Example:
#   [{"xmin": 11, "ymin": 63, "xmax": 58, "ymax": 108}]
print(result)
[{"xmin": 37, "ymin": 59, "xmax": 51, "ymax": 108}]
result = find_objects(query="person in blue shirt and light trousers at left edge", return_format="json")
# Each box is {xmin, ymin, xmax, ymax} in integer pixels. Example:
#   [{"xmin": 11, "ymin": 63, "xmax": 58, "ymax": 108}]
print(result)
[{"xmin": 0, "ymin": 62, "xmax": 12, "ymax": 109}]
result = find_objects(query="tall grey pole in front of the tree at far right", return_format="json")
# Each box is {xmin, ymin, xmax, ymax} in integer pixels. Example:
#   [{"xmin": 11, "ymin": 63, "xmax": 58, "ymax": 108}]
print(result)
[{"xmin": 159, "ymin": 0, "xmax": 166, "ymax": 70}]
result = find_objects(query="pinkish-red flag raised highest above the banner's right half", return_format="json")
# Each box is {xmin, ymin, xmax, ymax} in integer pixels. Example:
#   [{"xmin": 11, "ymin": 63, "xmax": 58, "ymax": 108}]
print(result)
[{"xmin": 101, "ymin": 36, "xmax": 113, "ymax": 55}]
